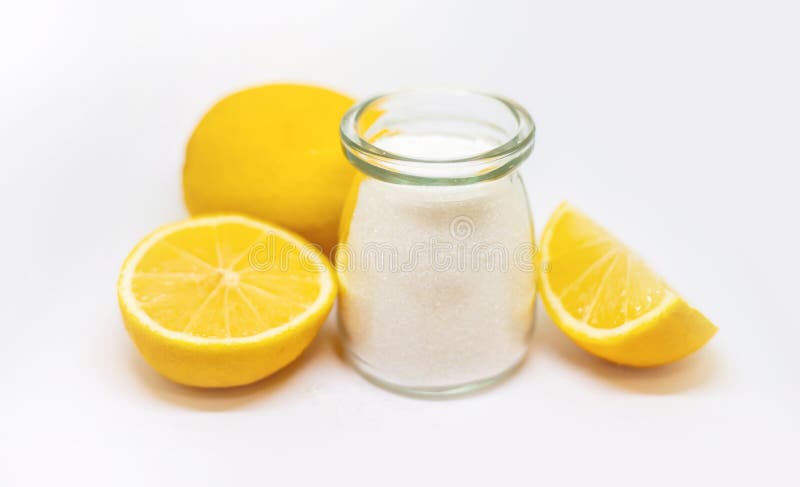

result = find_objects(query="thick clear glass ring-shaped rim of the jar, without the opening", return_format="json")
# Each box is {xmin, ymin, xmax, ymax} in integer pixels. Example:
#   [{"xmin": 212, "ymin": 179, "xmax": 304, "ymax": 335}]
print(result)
[{"xmin": 340, "ymin": 89, "xmax": 536, "ymax": 185}]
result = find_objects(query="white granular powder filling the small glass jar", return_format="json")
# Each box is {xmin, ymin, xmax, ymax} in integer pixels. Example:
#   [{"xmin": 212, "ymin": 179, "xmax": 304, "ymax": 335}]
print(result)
[{"xmin": 337, "ymin": 132, "xmax": 535, "ymax": 389}]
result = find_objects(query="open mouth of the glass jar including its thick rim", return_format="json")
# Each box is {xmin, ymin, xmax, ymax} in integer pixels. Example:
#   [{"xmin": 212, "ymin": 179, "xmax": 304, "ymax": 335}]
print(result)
[{"xmin": 341, "ymin": 90, "xmax": 535, "ymax": 185}]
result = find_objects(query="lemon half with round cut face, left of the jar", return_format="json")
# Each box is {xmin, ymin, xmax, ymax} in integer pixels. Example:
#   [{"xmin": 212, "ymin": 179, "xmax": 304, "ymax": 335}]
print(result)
[{"xmin": 117, "ymin": 214, "xmax": 336, "ymax": 387}]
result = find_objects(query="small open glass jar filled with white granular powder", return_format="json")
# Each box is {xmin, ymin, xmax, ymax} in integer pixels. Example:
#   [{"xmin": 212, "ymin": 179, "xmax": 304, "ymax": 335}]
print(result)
[{"xmin": 335, "ymin": 90, "xmax": 536, "ymax": 395}]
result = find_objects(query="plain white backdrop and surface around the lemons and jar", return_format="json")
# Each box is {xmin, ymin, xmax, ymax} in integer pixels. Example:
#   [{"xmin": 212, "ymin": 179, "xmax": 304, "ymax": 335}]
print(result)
[{"xmin": 0, "ymin": 0, "xmax": 800, "ymax": 486}]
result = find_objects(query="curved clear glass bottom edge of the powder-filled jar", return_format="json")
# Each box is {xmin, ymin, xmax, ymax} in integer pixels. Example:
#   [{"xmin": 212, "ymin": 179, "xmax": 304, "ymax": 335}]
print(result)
[{"xmin": 342, "ymin": 345, "xmax": 528, "ymax": 399}]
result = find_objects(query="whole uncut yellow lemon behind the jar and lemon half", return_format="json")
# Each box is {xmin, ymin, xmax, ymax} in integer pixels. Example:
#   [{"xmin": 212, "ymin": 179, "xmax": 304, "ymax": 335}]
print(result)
[{"xmin": 183, "ymin": 84, "xmax": 355, "ymax": 251}]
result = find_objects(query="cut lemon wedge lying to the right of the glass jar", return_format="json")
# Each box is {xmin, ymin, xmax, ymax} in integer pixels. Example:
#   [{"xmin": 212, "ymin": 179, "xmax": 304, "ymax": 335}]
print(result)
[{"xmin": 537, "ymin": 202, "xmax": 717, "ymax": 367}]
